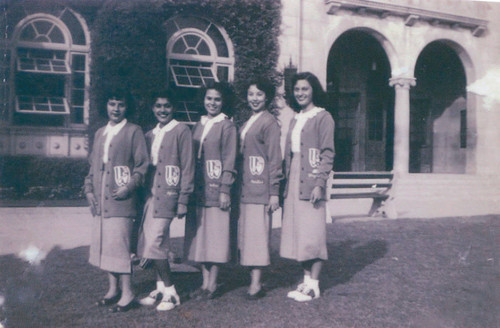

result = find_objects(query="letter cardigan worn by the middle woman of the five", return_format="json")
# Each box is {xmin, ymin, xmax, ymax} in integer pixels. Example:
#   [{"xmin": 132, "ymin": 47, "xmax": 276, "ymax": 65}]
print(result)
[{"xmin": 193, "ymin": 119, "xmax": 237, "ymax": 207}]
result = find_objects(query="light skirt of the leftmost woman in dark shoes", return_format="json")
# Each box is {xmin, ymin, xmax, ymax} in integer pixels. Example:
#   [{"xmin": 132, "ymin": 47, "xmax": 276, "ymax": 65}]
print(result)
[{"xmin": 89, "ymin": 174, "xmax": 133, "ymax": 273}]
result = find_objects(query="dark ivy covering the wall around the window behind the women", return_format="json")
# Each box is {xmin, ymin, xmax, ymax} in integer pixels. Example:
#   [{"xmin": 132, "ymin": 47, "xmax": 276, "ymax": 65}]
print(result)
[{"xmin": 89, "ymin": 0, "xmax": 281, "ymax": 137}]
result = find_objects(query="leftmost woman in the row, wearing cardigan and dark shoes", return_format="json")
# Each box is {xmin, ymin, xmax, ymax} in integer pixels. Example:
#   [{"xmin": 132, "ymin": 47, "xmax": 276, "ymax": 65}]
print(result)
[{"xmin": 85, "ymin": 90, "xmax": 149, "ymax": 312}]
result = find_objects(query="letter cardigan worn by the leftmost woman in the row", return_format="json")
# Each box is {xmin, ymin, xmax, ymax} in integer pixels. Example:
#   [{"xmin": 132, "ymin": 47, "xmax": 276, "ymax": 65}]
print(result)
[{"xmin": 84, "ymin": 122, "xmax": 149, "ymax": 218}]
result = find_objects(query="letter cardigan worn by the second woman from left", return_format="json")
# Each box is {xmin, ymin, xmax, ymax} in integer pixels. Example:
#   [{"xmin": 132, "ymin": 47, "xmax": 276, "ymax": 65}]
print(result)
[{"xmin": 146, "ymin": 123, "xmax": 194, "ymax": 218}]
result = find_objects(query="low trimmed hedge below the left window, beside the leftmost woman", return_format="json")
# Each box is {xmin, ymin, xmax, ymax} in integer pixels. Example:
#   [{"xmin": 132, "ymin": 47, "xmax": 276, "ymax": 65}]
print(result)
[{"xmin": 0, "ymin": 156, "xmax": 89, "ymax": 200}]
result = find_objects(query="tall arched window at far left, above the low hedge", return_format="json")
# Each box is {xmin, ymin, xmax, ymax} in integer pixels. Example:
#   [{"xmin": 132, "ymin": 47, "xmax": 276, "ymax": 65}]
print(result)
[{"xmin": 11, "ymin": 9, "xmax": 89, "ymax": 127}]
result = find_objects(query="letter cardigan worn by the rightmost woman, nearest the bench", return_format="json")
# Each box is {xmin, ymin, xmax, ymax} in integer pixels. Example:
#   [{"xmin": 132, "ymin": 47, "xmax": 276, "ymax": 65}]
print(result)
[{"xmin": 284, "ymin": 110, "xmax": 335, "ymax": 200}]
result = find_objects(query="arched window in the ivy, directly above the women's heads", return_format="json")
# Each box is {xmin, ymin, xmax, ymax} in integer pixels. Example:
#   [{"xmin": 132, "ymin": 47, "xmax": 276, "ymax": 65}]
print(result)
[{"xmin": 166, "ymin": 16, "xmax": 234, "ymax": 122}]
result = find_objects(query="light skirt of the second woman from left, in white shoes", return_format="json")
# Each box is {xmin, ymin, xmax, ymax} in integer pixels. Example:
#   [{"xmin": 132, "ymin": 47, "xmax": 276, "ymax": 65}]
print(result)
[{"xmin": 137, "ymin": 197, "xmax": 172, "ymax": 260}]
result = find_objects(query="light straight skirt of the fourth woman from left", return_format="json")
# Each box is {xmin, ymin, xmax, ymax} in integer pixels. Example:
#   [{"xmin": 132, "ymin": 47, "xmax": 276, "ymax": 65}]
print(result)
[{"xmin": 238, "ymin": 204, "xmax": 271, "ymax": 266}]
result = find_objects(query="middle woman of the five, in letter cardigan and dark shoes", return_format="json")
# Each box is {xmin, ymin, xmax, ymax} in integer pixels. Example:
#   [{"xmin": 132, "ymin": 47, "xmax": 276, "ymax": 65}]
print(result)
[{"xmin": 186, "ymin": 83, "xmax": 237, "ymax": 299}]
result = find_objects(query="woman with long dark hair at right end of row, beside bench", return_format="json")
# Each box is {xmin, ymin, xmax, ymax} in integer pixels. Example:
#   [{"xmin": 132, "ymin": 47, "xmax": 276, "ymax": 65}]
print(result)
[{"xmin": 280, "ymin": 72, "xmax": 334, "ymax": 302}]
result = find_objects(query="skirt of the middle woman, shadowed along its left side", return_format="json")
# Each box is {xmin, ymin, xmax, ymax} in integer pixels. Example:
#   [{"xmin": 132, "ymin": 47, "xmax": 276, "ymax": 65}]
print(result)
[{"xmin": 185, "ymin": 206, "xmax": 230, "ymax": 263}]
